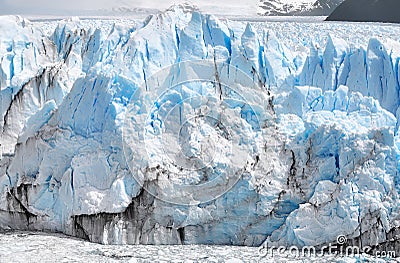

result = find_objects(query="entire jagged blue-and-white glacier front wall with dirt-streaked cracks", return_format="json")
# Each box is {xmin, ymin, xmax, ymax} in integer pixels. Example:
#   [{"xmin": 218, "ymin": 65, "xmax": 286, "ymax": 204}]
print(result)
[{"xmin": 0, "ymin": 6, "xmax": 400, "ymax": 252}]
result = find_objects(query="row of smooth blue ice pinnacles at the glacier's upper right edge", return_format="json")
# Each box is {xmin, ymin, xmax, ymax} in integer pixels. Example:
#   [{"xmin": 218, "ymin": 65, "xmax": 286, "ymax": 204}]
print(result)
[{"xmin": 296, "ymin": 36, "xmax": 400, "ymax": 125}]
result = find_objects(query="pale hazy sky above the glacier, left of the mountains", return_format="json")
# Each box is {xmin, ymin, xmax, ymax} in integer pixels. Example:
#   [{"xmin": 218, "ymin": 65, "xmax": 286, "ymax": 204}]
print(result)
[{"xmin": 0, "ymin": 0, "xmax": 258, "ymax": 15}]
